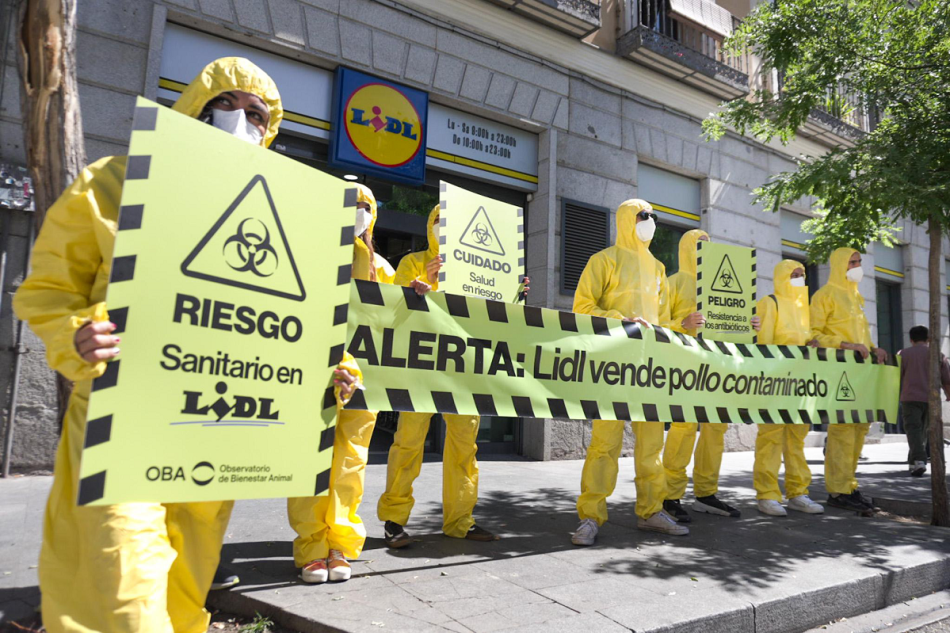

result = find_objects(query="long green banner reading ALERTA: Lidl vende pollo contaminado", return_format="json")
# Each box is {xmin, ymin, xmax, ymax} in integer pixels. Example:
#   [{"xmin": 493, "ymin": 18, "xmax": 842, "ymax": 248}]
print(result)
[{"xmin": 347, "ymin": 281, "xmax": 900, "ymax": 424}]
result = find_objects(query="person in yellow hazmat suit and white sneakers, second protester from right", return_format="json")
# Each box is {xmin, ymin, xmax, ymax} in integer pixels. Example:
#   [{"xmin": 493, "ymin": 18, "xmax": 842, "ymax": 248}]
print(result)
[{"xmin": 753, "ymin": 259, "xmax": 825, "ymax": 517}]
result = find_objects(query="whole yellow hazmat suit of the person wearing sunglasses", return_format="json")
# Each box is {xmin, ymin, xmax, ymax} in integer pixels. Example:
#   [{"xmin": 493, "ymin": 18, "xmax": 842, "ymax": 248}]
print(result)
[{"xmin": 574, "ymin": 200, "xmax": 670, "ymax": 525}]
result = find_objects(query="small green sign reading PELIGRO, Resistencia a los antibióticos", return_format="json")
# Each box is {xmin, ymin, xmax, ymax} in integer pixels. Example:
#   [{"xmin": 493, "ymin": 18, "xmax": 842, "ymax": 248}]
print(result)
[{"xmin": 696, "ymin": 242, "xmax": 756, "ymax": 343}]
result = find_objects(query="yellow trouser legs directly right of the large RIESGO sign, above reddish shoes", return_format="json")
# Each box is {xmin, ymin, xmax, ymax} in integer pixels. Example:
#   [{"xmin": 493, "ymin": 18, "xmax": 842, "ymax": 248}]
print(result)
[{"xmin": 287, "ymin": 409, "xmax": 376, "ymax": 567}]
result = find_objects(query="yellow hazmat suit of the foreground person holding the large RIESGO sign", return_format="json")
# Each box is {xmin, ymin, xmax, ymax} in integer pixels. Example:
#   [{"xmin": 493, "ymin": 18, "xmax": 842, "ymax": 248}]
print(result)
[{"xmin": 13, "ymin": 57, "xmax": 283, "ymax": 633}]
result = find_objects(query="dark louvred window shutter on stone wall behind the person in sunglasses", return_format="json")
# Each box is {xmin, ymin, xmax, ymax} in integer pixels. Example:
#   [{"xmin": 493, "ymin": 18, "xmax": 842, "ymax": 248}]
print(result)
[{"xmin": 561, "ymin": 199, "xmax": 610, "ymax": 295}]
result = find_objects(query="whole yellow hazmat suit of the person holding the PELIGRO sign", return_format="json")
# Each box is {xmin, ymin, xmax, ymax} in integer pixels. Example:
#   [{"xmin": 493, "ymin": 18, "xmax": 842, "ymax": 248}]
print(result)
[{"xmin": 663, "ymin": 229, "xmax": 729, "ymax": 499}]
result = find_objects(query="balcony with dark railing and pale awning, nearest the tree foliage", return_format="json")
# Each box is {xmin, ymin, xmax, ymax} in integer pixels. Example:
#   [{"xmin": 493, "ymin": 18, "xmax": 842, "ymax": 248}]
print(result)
[{"xmin": 617, "ymin": 0, "xmax": 752, "ymax": 99}]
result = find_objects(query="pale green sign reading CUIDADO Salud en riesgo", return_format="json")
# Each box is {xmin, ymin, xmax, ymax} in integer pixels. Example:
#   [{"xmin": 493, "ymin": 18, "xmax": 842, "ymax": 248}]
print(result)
[{"xmin": 439, "ymin": 182, "xmax": 524, "ymax": 302}]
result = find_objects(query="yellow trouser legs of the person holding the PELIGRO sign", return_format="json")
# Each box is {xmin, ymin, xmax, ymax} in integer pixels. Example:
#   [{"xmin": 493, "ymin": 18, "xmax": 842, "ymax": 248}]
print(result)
[{"xmin": 663, "ymin": 422, "xmax": 729, "ymax": 499}]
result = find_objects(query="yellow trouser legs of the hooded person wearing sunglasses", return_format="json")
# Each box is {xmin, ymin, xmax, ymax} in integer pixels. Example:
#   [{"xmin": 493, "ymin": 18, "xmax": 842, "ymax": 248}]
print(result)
[{"xmin": 577, "ymin": 420, "xmax": 666, "ymax": 525}]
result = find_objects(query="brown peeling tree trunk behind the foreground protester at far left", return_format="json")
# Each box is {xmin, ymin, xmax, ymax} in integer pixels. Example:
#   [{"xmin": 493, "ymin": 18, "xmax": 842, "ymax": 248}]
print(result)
[{"xmin": 16, "ymin": 0, "xmax": 86, "ymax": 425}]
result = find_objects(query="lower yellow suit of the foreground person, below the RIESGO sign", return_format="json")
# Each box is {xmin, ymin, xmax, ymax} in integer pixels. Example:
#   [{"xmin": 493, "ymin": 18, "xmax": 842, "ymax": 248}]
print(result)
[{"xmin": 39, "ymin": 383, "xmax": 234, "ymax": 633}]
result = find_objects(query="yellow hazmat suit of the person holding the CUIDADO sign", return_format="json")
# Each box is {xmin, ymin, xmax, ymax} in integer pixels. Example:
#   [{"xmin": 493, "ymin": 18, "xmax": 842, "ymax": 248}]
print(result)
[{"xmin": 377, "ymin": 205, "xmax": 480, "ymax": 538}]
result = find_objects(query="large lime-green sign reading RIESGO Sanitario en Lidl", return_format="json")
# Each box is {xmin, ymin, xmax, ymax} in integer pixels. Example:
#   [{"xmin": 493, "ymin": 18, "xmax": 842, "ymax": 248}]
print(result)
[{"xmin": 78, "ymin": 98, "xmax": 356, "ymax": 505}]
